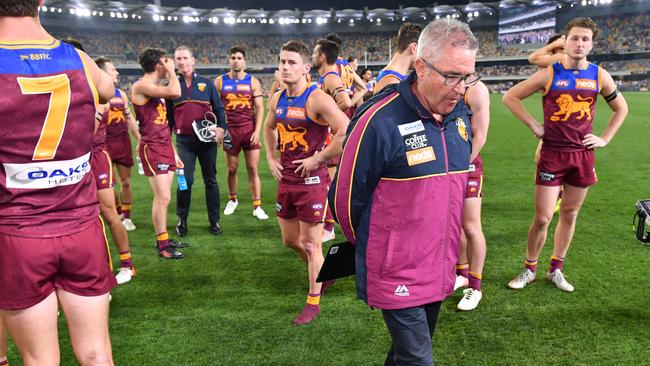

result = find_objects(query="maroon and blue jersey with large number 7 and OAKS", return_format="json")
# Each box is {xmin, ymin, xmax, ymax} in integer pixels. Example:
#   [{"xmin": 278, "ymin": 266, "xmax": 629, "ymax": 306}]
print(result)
[{"xmin": 0, "ymin": 39, "xmax": 99, "ymax": 238}]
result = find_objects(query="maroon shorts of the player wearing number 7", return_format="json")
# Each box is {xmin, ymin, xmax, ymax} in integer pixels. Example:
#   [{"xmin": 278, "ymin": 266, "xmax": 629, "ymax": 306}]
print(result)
[{"xmin": 0, "ymin": 217, "xmax": 117, "ymax": 310}]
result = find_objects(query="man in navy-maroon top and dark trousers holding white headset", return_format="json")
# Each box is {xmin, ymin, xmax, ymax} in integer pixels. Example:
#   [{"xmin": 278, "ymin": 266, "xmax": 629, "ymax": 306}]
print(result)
[{"xmin": 167, "ymin": 46, "xmax": 226, "ymax": 236}]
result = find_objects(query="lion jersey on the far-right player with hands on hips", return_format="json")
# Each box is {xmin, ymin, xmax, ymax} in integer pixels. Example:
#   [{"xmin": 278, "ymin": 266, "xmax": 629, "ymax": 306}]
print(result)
[{"xmin": 542, "ymin": 62, "xmax": 600, "ymax": 151}]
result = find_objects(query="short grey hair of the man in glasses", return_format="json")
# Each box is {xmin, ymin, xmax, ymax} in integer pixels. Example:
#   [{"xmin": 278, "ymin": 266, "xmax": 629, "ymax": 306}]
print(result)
[{"xmin": 416, "ymin": 18, "xmax": 478, "ymax": 60}]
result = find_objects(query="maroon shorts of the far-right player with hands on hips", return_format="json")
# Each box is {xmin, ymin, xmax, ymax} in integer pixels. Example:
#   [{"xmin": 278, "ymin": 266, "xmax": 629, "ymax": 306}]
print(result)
[{"xmin": 535, "ymin": 147, "xmax": 598, "ymax": 187}]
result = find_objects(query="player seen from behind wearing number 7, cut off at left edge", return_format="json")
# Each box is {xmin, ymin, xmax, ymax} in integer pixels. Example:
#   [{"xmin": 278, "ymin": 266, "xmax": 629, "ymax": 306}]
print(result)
[{"xmin": 0, "ymin": 0, "xmax": 115, "ymax": 366}]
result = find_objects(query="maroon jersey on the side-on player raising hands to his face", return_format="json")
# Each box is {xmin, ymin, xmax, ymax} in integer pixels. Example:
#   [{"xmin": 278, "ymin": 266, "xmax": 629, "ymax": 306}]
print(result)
[{"xmin": 133, "ymin": 98, "xmax": 172, "ymax": 145}]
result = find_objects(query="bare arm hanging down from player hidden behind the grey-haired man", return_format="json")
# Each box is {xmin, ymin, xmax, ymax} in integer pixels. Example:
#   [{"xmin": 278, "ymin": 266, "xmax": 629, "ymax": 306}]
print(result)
[{"xmin": 467, "ymin": 81, "xmax": 490, "ymax": 161}]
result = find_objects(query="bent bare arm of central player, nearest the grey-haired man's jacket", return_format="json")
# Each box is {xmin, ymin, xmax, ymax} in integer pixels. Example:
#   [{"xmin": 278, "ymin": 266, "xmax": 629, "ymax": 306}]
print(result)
[{"xmin": 293, "ymin": 90, "xmax": 350, "ymax": 177}]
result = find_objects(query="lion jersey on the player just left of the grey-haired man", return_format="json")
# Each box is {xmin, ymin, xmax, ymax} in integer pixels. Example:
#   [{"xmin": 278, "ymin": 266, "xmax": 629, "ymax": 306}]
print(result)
[{"xmin": 275, "ymin": 85, "xmax": 329, "ymax": 185}]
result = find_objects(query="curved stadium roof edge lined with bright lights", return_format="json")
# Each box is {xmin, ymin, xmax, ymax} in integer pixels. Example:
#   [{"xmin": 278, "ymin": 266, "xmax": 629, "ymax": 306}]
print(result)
[{"xmin": 40, "ymin": 0, "xmax": 623, "ymax": 26}]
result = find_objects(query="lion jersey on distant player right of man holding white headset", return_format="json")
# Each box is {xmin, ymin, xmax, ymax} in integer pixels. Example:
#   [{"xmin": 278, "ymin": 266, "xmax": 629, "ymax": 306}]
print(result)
[{"xmin": 218, "ymin": 73, "xmax": 255, "ymax": 127}]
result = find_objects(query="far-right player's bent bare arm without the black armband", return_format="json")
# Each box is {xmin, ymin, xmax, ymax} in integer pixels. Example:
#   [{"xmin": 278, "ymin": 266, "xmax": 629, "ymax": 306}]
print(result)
[{"xmin": 502, "ymin": 69, "xmax": 551, "ymax": 138}]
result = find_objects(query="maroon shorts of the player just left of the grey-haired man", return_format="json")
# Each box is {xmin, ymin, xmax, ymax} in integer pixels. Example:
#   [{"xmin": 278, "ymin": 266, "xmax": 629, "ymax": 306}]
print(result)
[{"xmin": 275, "ymin": 184, "xmax": 328, "ymax": 223}]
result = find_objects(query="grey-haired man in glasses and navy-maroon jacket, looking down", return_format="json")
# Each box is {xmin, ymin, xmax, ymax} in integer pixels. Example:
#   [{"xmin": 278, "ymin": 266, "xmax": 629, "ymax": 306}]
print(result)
[{"xmin": 329, "ymin": 19, "xmax": 479, "ymax": 365}]
